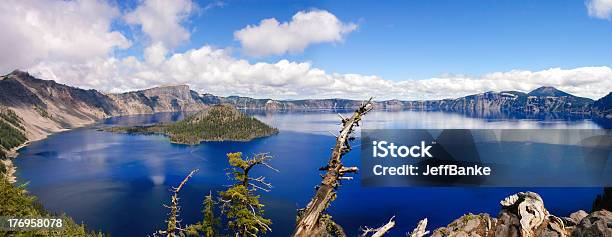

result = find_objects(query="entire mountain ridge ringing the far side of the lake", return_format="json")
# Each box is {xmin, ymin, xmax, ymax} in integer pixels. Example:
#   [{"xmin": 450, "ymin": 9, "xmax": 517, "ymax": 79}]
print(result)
[{"xmin": 0, "ymin": 70, "xmax": 612, "ymax": 143}]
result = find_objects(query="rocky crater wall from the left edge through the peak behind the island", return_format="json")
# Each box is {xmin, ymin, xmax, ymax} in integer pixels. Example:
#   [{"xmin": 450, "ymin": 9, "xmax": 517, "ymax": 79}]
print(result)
[{"xmin": 0, "ymin": 71, "xmax": 207, "ymax": 141}]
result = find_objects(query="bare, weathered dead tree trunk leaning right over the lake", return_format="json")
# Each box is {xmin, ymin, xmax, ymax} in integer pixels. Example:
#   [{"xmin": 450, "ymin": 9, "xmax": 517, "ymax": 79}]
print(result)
[{"xmin": 293, "ymin": 98, "xmax": 372, "ymax": 237}]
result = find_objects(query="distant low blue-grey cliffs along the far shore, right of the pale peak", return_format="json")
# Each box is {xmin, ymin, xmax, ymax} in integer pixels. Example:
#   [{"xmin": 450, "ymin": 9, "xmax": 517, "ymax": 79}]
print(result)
[{"xmin": 215, "ymin": 87, "xmax": 611, "ymax": 115}]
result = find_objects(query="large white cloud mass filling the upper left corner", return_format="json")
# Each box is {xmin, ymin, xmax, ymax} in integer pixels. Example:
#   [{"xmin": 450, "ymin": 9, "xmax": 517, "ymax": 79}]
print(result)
[{"xmin": 0, "ymin": 0, "xmax": 130, "ymax": 72}]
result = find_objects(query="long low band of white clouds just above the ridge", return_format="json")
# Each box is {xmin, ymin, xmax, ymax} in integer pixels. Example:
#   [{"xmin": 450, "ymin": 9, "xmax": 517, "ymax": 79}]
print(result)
[{"xmin": 32, "ymin": 46, "xmax": 612, "ymax": 100}]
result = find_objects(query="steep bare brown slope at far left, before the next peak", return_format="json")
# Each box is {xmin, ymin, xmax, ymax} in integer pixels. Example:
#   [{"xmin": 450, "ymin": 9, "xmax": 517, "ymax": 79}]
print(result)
[{"xmin": 0, "ymin": 71, "xmax": 116, "ymax": 140}]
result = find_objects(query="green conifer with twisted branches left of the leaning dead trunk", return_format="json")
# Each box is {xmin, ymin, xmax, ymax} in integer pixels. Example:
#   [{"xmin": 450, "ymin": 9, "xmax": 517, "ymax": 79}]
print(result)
[{"xmin": 219, "ymin": 152, "xmax": 276, "ymax": 237}]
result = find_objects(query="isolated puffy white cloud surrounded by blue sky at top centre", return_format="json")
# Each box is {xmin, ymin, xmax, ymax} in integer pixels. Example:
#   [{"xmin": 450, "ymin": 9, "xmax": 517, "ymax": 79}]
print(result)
[{"xmin": 234, "ymin": 10, "xmax": 357, "ymax": 56}]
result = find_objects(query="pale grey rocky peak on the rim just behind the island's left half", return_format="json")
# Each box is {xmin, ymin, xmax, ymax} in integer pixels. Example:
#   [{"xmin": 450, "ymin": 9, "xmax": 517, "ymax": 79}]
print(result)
[{"xmin": 108, "ymin": 85, "xmax": 207, "ymax": 115}]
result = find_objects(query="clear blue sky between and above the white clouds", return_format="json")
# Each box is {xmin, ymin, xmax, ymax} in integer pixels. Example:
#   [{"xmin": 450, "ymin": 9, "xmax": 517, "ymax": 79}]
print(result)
[{"xmin": 116, "ymin": 0, "xmax": 612, "ymax": 80}]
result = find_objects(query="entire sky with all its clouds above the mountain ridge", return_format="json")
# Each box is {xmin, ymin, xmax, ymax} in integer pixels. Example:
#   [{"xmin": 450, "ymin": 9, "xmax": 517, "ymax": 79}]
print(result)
[{"xmin": 0, "ymin": 0, "xmax": 612, "ymax": 100}]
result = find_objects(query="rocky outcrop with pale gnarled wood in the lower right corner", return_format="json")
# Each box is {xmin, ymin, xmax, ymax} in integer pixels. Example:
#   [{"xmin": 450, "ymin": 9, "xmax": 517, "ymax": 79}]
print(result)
[{"xmin": 432, "ymin": 192, "xmax": 612, "ymax": 237}]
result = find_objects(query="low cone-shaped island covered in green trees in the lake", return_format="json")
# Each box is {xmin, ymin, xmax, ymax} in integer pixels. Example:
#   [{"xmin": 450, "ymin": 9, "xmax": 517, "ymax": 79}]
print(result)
[{"xmin": 103, "ymin": 104, "xmax": 278, "ymax": 145}]
